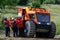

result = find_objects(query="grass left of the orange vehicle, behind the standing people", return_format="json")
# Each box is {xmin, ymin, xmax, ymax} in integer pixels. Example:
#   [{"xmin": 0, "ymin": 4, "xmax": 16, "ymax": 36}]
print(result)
[{"xmin": 0, "ymin": 9, "xmax": 17, "ymax": 30}]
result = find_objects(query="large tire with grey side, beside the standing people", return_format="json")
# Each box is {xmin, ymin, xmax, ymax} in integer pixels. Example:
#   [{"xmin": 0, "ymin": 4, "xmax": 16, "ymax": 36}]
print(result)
[{"xmin": 25, "ymin": 21, "xmax": 35, "ymax": 37}]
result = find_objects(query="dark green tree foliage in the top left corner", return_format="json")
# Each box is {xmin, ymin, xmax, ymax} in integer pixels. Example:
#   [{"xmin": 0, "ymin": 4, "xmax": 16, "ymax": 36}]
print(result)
[{"xmin": 0, "ymin": 0, "xmax": 20, "ymax": 8}]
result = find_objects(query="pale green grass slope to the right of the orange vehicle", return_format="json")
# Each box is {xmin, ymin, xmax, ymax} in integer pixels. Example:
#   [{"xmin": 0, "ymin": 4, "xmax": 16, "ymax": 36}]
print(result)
[{"xmin": 42, "ymin": 4, "xmax": 60, "ymax": 35}]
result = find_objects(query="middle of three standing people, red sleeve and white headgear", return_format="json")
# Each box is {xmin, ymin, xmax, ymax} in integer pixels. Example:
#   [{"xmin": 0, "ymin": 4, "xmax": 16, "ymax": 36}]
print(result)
[{"xmin": 9, "ymin": 18, "xmax": 18, "ymax": 37}]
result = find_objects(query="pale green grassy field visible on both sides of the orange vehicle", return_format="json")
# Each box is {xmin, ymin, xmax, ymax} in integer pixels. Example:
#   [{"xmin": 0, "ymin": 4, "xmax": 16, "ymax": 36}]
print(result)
[{"xmin": 0, "ymin": 4, "xmax": 60, "ymax": 35}]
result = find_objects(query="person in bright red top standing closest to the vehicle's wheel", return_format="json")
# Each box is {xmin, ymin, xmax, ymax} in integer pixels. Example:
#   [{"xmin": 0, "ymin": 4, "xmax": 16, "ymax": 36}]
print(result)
[{"xmin": 15, "ymin": 16, "xmax": 24, "ymax": 37}]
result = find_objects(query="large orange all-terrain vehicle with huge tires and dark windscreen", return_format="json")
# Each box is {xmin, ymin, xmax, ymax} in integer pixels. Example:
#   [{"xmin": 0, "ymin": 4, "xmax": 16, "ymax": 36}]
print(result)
[{"xmin": 18, "ymin": 7, "xmax": 56, "ymax": 38}]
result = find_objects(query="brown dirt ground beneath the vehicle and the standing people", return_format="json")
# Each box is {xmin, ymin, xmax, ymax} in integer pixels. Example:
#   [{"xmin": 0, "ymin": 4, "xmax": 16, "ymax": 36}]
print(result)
[{"xmin": 0, "ymin": 31, "xmax": 60, "ymax": 40}]
